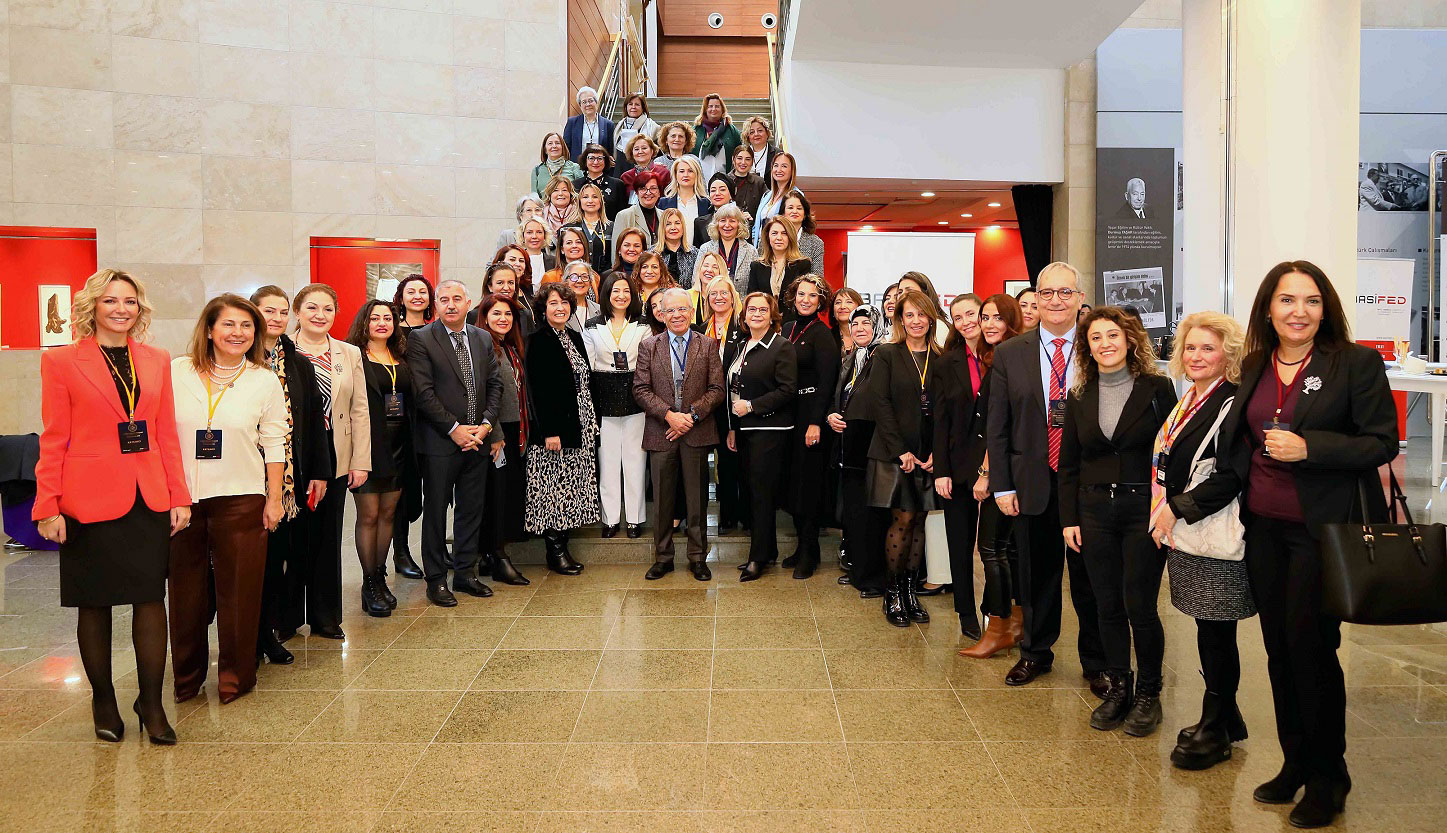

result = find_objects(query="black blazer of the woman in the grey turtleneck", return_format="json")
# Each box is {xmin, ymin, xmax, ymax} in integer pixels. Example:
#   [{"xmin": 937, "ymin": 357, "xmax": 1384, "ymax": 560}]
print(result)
[{"xmin": 1059, "ymin": 375, "xmax": 1176, "ymax": 526}]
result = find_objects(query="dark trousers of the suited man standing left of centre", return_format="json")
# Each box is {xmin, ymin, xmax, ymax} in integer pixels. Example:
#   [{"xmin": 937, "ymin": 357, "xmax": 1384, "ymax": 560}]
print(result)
[{"xmin": 417, "ymin": 451, "xmax": 492, "ymax": 583}]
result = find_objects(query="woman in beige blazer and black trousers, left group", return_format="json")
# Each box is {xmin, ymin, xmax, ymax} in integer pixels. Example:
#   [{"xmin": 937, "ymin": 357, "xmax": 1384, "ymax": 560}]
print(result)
[{"xmin": 278, "ymin": 283, "xmax": 372, "ymax": 642}]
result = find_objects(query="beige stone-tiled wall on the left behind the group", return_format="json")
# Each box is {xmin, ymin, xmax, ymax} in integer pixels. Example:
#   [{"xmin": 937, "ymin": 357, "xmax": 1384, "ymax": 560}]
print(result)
[{"xmin": 0, "ymin": 0, "xmax": 567, "ymax": 432}]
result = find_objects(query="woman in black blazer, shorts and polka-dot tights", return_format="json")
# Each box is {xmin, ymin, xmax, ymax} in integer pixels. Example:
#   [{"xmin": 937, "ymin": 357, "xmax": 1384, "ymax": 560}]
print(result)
[{"xmin": 868, "ymin": 289, "xmax": 941, "ymax": 628}]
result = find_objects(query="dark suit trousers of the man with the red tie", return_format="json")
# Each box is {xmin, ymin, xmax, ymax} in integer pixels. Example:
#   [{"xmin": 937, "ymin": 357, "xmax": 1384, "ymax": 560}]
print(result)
[{"xmin": 1014, "ymin": 473, "xmax": 1106, "ymax": 672}]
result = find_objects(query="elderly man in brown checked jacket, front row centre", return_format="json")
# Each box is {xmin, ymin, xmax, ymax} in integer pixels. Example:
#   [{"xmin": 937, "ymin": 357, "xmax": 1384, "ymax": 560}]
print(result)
[{"xmin": 634, "ymin": 288, "xmax": 724, "ymax": 581}]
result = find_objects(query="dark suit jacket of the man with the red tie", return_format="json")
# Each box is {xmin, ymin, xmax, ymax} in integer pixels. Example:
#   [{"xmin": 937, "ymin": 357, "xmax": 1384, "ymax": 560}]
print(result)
[{"xmin": 985, "ymin": 328, "xmax": 1079, "ymax": 515}]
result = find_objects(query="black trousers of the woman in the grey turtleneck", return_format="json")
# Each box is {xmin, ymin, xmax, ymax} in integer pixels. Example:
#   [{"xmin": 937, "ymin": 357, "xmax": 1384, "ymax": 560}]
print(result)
[{"xmin": 1072, "ymin": 484, "xmax": 1166, "ymax": 693}]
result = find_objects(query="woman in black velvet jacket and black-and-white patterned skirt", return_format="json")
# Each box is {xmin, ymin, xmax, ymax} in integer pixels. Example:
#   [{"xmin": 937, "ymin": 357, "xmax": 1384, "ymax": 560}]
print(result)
[{"xmin": 527, "ymin": 283, "xmax": 598, "ymax": 576}]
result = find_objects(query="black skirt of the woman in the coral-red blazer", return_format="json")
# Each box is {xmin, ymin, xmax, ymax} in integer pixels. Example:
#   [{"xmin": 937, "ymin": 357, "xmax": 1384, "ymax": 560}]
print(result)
[{"xmin": 61, "ymin": 489, "xmax": 171, "ymax": 607}]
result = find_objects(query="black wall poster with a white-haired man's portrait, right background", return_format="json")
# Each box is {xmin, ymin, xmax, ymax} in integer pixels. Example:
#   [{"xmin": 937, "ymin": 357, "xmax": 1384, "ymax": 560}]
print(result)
[{"xmin": 1095, "ymin": 148, "xmax": 1178, "ymax": 337}]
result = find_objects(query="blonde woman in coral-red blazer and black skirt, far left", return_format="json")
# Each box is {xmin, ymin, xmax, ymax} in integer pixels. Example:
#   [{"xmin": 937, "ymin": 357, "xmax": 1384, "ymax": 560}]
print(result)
[{"xmin": 33, "ymin": 269, "xmax": 191, "ymax": 743}]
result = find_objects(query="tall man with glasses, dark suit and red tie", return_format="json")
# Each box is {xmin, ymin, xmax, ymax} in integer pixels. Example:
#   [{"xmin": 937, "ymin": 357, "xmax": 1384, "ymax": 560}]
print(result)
[{"xmin": 985, "ymin": 262, "xmax": 1106, "ymax": 688}]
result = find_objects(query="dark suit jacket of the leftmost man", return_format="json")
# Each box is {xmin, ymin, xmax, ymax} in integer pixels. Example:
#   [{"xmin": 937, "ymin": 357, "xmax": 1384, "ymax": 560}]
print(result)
[{"xmin": 407, "ymin": 320, "xmax": 502, "ymax": 457}]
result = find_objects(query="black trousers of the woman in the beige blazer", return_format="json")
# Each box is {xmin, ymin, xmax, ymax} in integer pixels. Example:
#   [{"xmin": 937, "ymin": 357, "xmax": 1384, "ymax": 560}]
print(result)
[{"xmin": 279, "ymin": 477, "xmax": 347, "ymax": 631}]
